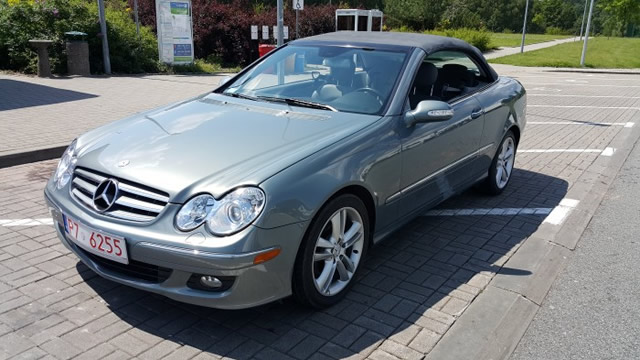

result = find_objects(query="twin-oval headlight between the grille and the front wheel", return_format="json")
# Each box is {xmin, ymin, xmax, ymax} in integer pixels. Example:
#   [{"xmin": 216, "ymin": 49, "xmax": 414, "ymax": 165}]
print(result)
[{"xmin": 176, "ymin": 187, "xmax": 265, "ymax": 236}]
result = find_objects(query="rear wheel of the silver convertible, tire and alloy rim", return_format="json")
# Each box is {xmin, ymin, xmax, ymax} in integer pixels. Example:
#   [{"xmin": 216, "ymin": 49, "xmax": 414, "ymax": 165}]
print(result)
[{"xmin": 481, "ymin": 130, "xmax": 518, "ymax": 195}]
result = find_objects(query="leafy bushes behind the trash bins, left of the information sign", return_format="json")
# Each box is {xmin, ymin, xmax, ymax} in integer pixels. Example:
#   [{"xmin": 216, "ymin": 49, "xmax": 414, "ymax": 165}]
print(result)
[{"xmin": 0, "ymin": 0, "xmax": 158, "ymax": 74}]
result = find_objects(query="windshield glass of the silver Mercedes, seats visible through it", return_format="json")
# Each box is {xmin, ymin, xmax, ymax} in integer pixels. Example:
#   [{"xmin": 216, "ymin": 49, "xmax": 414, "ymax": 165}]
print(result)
[{"xmin": 223, "ymin": 45, "xmax": 407, "ymax": 114}]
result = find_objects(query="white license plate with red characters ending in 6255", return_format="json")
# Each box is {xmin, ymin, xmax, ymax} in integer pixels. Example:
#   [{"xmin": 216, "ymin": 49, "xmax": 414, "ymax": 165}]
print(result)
[{"xmin": 62, "ymin": 214, "xmax": 129, "ymax": 264}]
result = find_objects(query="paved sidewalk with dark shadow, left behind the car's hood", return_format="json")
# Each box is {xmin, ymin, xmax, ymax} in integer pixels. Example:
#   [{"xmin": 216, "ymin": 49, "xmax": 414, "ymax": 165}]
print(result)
[{"xmin": 0, "ymin": 74, "xmax": 223, "ymax": 168}]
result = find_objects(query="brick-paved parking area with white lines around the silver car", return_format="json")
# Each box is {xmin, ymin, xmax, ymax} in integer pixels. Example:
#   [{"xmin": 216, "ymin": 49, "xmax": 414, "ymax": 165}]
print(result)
[{"xmin": 0, "ymin": 70, "xmax": 640, "ymax": 359}]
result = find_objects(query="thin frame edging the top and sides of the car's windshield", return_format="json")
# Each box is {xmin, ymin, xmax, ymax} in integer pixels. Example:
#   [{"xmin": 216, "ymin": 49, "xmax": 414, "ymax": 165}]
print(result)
[{"xmin": 212, "ymin": 39, "xmax": 415, "ymax": 116}]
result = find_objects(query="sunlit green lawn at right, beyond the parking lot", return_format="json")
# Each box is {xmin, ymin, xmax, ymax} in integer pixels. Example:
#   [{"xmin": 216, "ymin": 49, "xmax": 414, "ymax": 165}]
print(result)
[{"xmin": 489, "ymin": 37, "xmax": 640, "ymax": 69}]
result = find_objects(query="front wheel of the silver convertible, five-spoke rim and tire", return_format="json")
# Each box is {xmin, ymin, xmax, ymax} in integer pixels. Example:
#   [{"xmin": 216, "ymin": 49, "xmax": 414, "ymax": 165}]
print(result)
[{"xmin": 292, "ymin": 194, "xmax": 370, "ymax": 309}]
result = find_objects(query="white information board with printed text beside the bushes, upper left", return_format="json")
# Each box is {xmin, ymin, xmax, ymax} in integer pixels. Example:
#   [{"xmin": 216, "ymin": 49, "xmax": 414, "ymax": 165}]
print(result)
[{"xmin": 156, "ymin": 0, "xmax": 194, "ymax": 64}]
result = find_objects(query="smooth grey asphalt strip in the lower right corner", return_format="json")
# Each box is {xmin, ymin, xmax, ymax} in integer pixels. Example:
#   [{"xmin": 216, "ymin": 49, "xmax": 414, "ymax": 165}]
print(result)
[{"xmin": 511, "ymin": 128, "xmax": 640, "ymax": 360}]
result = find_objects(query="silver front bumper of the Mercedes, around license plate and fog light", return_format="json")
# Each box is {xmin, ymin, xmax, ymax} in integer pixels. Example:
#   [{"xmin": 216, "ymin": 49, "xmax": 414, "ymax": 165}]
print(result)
[{"xmin": 45, "ymin": 187, "xmax": 306, "ymax": 309}]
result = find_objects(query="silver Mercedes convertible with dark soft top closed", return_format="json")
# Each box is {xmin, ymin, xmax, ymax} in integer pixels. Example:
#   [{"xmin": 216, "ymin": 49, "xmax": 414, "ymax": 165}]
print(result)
[{"xmin": 45, "ymin": 32, "xmax": 526, "ymax": 309}]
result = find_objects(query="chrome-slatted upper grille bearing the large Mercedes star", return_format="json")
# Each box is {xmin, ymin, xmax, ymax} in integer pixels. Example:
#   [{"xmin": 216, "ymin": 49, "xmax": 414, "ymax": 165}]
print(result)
[{"xmin": 71, "ymin": 168, "xmax": 169, "ymax": 222}]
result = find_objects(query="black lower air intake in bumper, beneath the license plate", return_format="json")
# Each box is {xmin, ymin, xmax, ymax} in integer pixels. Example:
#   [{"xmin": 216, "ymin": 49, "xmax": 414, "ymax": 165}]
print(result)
[{"xmin": 78, "ymin": 247, "xmax": 171, "ymax": 284}]
